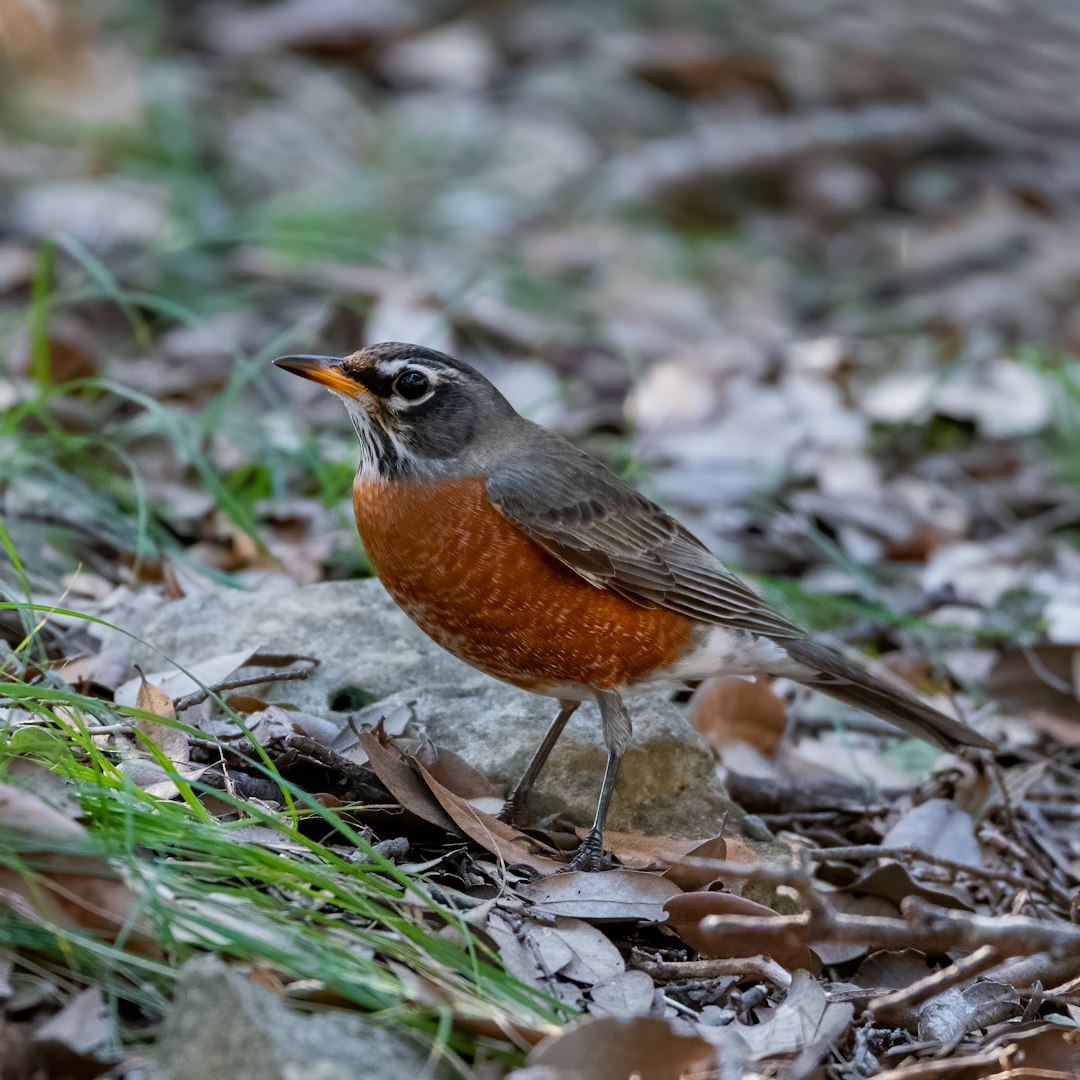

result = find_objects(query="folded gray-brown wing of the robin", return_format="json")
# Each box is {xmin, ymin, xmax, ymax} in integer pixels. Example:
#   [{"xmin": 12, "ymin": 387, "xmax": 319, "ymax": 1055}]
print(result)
[{"xmin": 486, "ymin": 432, "xmax": 805, "ymax": 639}]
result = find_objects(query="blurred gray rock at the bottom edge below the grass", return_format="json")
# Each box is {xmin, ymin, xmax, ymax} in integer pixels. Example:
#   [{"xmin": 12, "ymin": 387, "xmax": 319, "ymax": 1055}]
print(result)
[{"xmin": 153, "ymin": 956, "xmax": 440, "ymax": 1080}]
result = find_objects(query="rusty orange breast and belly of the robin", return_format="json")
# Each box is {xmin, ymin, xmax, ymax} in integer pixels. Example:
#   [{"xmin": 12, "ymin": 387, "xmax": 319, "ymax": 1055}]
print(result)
[{"xmin": 353, "ymin": 477, "xmax": 692, "ymax": 690}]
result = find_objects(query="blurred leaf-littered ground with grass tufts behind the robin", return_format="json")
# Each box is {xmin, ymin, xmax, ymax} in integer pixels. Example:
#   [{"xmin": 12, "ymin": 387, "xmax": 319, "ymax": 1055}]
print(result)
[{"xmin": 0, "ymin": 0, "xmax": 1080, "ymax": 726}]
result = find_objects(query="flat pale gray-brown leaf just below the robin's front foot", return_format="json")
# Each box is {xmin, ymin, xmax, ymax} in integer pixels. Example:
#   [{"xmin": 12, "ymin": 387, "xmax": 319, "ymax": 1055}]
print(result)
[{"xmin": 517, "ymin": 870, "xmax": 681, "ymax": 922}]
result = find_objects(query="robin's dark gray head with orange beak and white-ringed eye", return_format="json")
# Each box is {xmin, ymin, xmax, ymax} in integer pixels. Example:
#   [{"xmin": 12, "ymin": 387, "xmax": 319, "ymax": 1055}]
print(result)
[{"xmin": 274, "ymin": 341, "xmax": 517, "ymax": 476}]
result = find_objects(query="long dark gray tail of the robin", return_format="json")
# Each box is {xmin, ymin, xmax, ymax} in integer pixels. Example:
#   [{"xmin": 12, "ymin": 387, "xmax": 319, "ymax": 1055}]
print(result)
[{"xmin": 783, "ymin": 639, "xmax": 994, "ymax": 750}]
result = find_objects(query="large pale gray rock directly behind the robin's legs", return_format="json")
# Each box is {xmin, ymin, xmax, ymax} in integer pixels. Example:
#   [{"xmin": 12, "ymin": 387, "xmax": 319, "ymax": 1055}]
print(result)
[{"xmin": 132, "ymin": 580, "xmax": 743, "ymax": 837}]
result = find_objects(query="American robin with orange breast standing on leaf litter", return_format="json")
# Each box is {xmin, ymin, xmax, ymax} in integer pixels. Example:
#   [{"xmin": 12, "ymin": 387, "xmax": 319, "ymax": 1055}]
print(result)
[{"xmin": 274, "ymin": 342, "xmax": 993, "ymax": 869}]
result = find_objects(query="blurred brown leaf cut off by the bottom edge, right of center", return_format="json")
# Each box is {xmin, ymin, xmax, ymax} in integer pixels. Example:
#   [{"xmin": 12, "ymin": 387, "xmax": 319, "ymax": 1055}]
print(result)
[{"xmin": 527, "ymin": 1017, "xmax": 714, "ymax": 1080}]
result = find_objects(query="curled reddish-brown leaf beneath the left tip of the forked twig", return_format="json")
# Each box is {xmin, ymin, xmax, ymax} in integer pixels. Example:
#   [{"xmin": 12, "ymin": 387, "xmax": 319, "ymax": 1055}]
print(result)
[{"xmin": 664, "ymin": 892, "xmax": 821, "ymax": 971}]
